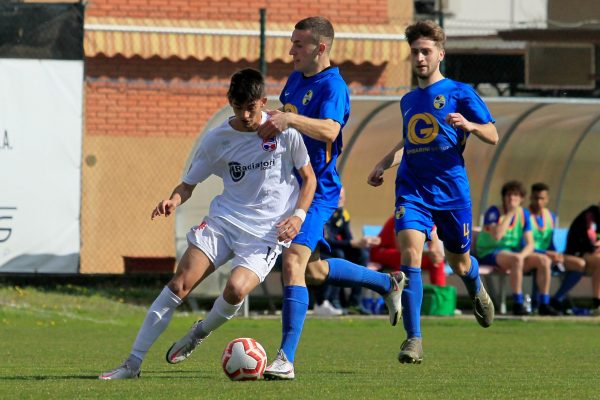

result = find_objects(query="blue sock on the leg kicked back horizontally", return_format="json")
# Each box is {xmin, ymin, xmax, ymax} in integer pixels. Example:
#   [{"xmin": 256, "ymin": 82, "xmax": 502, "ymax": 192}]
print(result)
[{"xmin": 325, "ymin": 258, "xmax": 392, "ymax": 295}]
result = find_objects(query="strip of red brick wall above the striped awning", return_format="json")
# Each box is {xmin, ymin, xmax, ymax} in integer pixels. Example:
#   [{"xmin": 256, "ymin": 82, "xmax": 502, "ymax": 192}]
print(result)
[{"xmin": 86, "ymin": 0, "xmax": 394, "ymax": 24}]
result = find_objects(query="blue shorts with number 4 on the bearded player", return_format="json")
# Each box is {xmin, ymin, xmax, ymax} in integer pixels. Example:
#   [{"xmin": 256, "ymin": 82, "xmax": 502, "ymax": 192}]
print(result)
[{"xmin": 394, "ymin": 201, "xmax": 472, "ymax": 254}]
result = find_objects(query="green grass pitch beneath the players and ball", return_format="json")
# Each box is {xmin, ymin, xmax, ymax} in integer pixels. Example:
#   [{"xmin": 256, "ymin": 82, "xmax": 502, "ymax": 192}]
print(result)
[{"xmin": 0, "ymin": 287, "xmax": 600, "ymax": 400}]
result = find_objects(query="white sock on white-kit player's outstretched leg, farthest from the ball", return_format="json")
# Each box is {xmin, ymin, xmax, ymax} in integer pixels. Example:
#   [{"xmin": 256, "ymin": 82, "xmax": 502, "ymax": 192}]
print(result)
[{"xmin": 131, "ymin": 286, "xmax": 181, "ymax": 363}]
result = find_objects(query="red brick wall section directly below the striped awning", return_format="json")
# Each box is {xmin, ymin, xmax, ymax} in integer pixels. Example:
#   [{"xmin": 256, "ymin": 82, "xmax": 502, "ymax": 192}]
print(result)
[{"xmin": 85, "ymin": 57, "xmax": 392, "ymax": 137}]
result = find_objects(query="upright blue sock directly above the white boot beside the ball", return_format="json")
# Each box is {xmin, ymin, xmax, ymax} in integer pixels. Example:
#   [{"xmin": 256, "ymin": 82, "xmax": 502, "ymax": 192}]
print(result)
[{"xmin": 281, "ymin": 286, "xmax": 308, "ymax": 363}]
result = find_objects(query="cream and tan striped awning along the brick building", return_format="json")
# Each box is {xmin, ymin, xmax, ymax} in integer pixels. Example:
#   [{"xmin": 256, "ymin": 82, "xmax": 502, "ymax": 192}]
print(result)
[{"xmin": 84, "ymin": 17, "xmax": 409, "ymax": 65}]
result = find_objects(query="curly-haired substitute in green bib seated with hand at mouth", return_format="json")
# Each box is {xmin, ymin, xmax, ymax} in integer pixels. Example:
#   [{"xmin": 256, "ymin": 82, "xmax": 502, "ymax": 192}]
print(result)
[{"xmin": 476, "ymin": 181, "xmax": 559, "ymax": 315}]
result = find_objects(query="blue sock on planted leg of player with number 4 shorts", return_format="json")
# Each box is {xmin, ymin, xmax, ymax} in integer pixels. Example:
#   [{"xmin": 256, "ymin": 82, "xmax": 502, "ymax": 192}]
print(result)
[{"xmin": 400, "ymin": 265, "xmax": 423, "ymax": 338}]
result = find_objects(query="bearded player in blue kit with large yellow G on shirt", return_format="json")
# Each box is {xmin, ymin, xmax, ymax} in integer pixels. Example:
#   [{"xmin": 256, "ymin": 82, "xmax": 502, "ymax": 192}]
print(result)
[{"xmin": 368, "ymin": 21, "xmax": 498, "ymax": 363}]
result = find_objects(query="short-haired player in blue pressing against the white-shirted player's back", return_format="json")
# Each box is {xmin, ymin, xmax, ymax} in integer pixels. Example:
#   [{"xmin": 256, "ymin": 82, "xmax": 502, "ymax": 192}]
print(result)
[{"xmin": 259, "ymin": 17, "xmax": 404, "ymax": 379}]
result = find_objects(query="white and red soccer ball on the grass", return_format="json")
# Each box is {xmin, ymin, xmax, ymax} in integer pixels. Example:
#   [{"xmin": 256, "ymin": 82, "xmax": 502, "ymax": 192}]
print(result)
[{"xmin": 221, "ymin": 338, "xmax": 267, "ymax": 381}]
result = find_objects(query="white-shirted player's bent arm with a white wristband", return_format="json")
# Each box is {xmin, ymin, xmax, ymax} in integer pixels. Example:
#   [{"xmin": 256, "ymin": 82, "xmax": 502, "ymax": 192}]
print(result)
[{"xmin": 277, "ymin": 163, "xmax": 317, "ymax": 242}]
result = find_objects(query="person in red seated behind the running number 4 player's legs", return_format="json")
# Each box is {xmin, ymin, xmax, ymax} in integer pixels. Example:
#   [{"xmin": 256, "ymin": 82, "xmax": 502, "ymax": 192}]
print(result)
[{"xmin": 369, "ymin": 215, "xmax": 446, "ymax": 286}]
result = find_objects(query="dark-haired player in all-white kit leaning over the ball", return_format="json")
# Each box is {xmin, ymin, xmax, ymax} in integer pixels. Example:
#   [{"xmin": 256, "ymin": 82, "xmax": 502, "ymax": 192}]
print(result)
[{"xmin": 100, "ymin": 69, "xmax": 316, "ymax": 380}]
